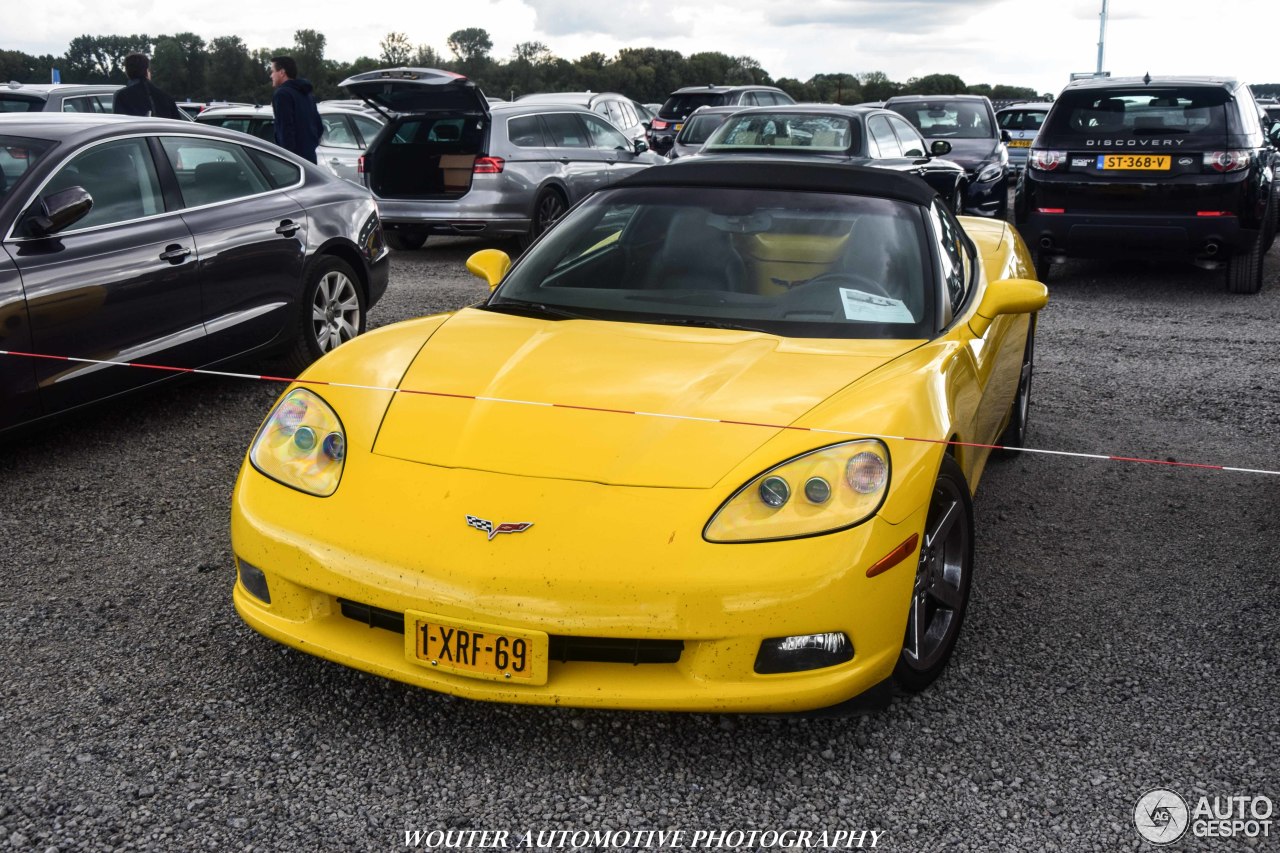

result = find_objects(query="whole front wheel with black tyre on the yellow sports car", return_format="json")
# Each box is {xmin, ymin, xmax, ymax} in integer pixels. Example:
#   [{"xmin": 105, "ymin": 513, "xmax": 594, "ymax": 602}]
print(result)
[{"xmin": 893, "ymin": 456, "xmax": 973, "ymax": 693}]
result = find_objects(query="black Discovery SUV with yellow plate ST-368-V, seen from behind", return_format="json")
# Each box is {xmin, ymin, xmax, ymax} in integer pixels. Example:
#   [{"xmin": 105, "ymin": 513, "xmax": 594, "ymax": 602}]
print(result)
[{"xmin": 1014, "ymin": 76, "xmax": 1280, "ymax": 293}]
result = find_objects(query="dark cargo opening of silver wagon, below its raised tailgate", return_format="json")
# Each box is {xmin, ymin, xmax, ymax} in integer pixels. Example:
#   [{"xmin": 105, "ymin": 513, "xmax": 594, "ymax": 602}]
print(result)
[{"xmin": 365, "ymin": 115, "xmax": 489, "ymax": 199}]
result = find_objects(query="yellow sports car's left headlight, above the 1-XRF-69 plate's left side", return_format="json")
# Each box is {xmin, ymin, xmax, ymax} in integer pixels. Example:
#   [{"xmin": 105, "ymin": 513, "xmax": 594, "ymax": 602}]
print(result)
[{"xmin": 248, "ymin": 388, "xmax": 347, "ymax": 497}]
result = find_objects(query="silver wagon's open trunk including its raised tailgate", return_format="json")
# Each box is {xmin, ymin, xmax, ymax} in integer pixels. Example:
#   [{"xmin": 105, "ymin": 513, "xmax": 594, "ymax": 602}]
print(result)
[{"xmin": 342, "ymin": 68, "xmax": 490, "ymax": 199}]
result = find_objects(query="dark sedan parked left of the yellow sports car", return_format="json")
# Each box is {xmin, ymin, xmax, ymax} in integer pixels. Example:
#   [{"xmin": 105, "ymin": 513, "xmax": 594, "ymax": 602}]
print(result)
[{"xmin": 0, "ymin": 113, "xmax": 388, "ymax": 430}]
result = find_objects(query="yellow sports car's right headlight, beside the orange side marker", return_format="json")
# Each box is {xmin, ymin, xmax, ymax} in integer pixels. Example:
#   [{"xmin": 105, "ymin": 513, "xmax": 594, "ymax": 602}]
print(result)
[{"xmin": 703, "ymin": 438, "xmax": 890, "ymax": 542}]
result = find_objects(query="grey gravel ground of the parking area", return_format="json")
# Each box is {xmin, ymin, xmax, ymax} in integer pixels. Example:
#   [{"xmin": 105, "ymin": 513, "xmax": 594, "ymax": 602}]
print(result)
[{"xmin": 0, "ymin": 234, "xmax": 1280, "ymax": 852}]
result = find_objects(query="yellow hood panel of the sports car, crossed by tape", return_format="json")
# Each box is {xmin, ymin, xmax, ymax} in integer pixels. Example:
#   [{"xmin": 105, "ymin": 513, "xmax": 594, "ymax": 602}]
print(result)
[{"xmin": 372, "ymin": 309, "xmax": 919, "ymax": 488}]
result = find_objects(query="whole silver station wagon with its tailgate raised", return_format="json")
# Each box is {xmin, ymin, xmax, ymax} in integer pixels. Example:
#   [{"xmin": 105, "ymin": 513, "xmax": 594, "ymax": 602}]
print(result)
[{"xmin": 342, "ymin": 68, "xmax": 666, "ymax": 250}]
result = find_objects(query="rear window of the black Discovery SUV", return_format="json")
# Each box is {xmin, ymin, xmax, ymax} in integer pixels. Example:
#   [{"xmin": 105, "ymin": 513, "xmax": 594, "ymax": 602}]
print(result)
[{"xmin": 1046, "ymin": 86, "xmax": 1230, "ymax": 136}]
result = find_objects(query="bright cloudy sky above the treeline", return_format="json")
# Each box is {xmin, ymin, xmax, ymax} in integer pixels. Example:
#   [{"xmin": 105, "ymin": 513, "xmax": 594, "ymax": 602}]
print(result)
[{"xmin": 0, "ymin": 0, "xmax": 1280, "ymax": 92}]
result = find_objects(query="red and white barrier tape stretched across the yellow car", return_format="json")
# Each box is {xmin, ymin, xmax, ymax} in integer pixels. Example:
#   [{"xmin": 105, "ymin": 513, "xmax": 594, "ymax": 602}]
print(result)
[{"xmin": 10, "ymin": 350, "xmax": 1280, "ymax": 476}]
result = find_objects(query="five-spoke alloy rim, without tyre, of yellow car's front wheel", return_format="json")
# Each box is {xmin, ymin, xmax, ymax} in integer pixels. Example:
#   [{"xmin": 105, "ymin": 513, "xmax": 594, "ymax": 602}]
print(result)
[{"xmin": 902, "ymin": 478, "xmax": 973, "ymax": 671}]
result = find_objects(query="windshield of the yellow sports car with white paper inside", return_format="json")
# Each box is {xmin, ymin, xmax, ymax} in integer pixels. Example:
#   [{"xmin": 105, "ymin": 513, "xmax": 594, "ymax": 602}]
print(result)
[{"xmin": 483, "ymin": 187, "xmax": 938, "ymax": 339}]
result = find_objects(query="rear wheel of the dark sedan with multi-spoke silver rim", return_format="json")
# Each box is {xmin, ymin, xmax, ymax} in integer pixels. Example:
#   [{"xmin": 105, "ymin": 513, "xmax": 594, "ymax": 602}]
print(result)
[{"xmin": 285, "ymin": 255, "xmax": 365, "ymax": 373}]
